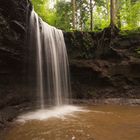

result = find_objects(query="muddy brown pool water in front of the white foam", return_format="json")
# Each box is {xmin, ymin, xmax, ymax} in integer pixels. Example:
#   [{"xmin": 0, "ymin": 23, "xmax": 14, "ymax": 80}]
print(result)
[{"xmin": 0, "ymin": 105, "xmax": 140, "ymax": 140}]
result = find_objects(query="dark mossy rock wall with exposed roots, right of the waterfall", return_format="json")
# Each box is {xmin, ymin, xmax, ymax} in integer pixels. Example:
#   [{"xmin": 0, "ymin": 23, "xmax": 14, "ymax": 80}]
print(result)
[{"xmin": 65, "ymin": 28, "xmax": 140, "ymax": 99}]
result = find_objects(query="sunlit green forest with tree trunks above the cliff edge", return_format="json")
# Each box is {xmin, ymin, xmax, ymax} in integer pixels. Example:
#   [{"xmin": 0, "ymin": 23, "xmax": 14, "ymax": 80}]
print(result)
[{"xmin": 32, "ymin": 0, "xmax": 140, "ymax": 31}]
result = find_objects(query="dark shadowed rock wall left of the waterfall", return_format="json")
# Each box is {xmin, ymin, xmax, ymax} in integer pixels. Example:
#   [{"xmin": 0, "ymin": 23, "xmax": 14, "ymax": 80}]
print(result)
[{"xmin": 0, "ymin": 0, "xmax": 31, "ymax": 108}]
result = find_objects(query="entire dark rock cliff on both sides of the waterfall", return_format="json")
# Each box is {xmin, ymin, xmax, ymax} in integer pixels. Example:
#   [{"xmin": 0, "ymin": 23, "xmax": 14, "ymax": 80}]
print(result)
[{"xmin": 0, "ymin": 0, "xmax": 140, "ymax": 108}]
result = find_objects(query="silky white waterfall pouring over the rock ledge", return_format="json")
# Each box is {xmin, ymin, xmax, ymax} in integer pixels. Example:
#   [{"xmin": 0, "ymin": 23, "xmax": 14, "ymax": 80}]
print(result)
[{"xmin": 29, "ymin": 11, "xmax": 71, "ymax": 109}]
